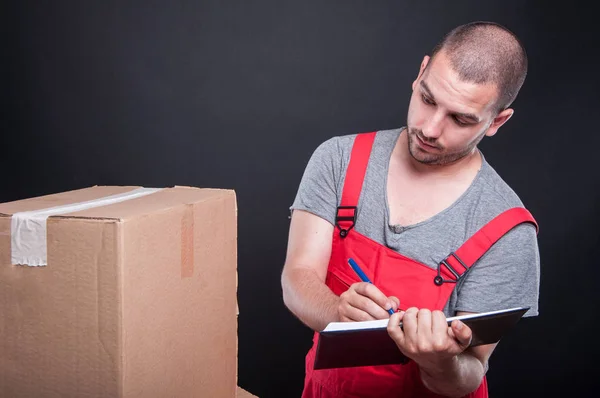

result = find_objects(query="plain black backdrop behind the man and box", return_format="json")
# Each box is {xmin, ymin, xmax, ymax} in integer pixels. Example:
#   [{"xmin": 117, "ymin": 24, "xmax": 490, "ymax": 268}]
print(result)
[{"xmin": 0, "ymin": 0, "xmax": 600, "ymax": 397}]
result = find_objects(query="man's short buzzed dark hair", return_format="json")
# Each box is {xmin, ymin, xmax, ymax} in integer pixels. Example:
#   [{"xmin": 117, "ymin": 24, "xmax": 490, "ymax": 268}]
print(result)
[{"xmin": 431, "ymin": 21, "xmax": 527, "ymax": 112}]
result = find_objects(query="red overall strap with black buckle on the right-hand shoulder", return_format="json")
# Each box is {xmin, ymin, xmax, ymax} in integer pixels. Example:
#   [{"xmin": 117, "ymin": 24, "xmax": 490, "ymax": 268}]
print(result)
[{"xmin": 434, "ymin": 207, "xmax": 539, "ymax": 285}]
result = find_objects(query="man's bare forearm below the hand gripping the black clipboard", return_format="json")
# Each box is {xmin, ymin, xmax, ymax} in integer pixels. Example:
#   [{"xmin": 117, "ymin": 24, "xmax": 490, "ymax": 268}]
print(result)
[{"xmin": 420, "ymin": 351, "xmax": 485, "ymax": 397}]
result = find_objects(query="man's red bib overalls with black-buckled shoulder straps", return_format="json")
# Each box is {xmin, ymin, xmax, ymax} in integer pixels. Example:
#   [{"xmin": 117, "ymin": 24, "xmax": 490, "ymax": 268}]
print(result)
[{"xmin": 302, "ymin": 133, "xmax": 537, "ymax": 398}]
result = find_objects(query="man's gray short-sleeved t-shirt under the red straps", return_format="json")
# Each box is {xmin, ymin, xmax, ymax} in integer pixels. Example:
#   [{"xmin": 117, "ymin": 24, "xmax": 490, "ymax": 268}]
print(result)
[{"xmin": 290, "ymin": 128, "xmax": 540, "ymax": 316}]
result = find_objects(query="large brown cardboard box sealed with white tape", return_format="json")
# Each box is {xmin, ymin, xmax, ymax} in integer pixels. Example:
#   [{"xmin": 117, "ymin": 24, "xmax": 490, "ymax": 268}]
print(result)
[{"xmin": 0, "ymin": 187, "xmax": 237, "ymax": 398}]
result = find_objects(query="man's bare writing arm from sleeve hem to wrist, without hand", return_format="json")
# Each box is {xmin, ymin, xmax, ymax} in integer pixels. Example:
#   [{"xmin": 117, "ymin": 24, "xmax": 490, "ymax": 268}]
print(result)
[{"xmin": 281, "ymin": 210, "xmax": 340, "ymax": 331}]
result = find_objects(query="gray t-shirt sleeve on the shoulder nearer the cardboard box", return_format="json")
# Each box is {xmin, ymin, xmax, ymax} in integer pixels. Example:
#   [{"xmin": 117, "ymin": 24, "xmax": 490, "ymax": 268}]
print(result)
[{"xmin": 290, "ymin": 137, "xmax": 343, "ymax": 225}]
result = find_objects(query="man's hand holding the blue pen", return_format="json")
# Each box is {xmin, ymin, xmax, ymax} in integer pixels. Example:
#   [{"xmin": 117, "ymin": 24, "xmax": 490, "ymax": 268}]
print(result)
[{"xmin": 338, "ymin": 282, "xmax": 400, "ymax": 322}]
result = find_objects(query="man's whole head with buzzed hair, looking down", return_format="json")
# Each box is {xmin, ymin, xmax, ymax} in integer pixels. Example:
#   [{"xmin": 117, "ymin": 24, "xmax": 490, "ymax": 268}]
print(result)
[{"xmin": 407, "ymin": 22, "xmax": 527, "ymax": 165}]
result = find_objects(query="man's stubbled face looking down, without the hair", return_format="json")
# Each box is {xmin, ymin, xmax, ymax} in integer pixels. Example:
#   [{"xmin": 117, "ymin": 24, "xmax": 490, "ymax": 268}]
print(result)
[{"xmin": 407, "ymin": 51, "xmax": 502, "ymax": 165}]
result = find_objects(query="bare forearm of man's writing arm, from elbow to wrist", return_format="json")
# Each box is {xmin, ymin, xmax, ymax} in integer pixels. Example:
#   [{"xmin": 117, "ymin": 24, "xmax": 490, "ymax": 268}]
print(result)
[{"xmin": 281, "ymin": 268, "xmax": 339, "ymax": 331}]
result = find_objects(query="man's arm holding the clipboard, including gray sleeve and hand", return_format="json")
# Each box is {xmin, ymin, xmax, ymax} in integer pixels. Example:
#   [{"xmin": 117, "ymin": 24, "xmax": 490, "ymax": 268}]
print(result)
[{"xmin": 388, "ymin": 224, "xmax": 540, "ymax": 397}]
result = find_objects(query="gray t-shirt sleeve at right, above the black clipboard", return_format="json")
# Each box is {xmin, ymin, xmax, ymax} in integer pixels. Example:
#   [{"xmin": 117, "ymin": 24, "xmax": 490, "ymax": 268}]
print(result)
[{"xmin": 455, "ymin": 223, "xmax": 540, "ymax": 317}]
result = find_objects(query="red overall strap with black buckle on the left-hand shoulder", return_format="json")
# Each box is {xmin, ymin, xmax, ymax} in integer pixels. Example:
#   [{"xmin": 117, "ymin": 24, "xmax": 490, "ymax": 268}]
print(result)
[{"xmin": 336, "ymin": 131, "xmax": 377, "ymax": 237}]
